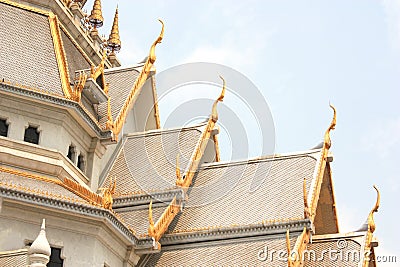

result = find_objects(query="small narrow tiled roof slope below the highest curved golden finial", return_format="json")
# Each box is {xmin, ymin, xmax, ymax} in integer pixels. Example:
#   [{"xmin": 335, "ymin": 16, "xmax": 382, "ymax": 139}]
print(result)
[{"xmin": 99, "ymin": 67, "xmax": 140, "ymax": 124}]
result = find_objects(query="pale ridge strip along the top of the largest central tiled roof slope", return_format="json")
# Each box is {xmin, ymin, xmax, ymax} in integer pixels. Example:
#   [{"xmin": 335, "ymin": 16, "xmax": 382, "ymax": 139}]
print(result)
[{"xmin": 199, "ymin": 148, "xmax": 321, "ymax": 170}]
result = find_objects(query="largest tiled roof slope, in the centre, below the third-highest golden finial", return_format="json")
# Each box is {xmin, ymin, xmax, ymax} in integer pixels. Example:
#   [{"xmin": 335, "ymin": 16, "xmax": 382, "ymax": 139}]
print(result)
[{"xmin": 169, "ymin": 150, "xmax": 320, "ymax": 232}]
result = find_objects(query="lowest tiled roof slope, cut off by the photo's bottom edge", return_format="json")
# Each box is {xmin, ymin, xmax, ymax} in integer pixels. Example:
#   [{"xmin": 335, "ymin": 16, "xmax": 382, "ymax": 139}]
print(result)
[{"xmin": 146, "ymin": 234, "xmax": 297, "ymax": 267}]
